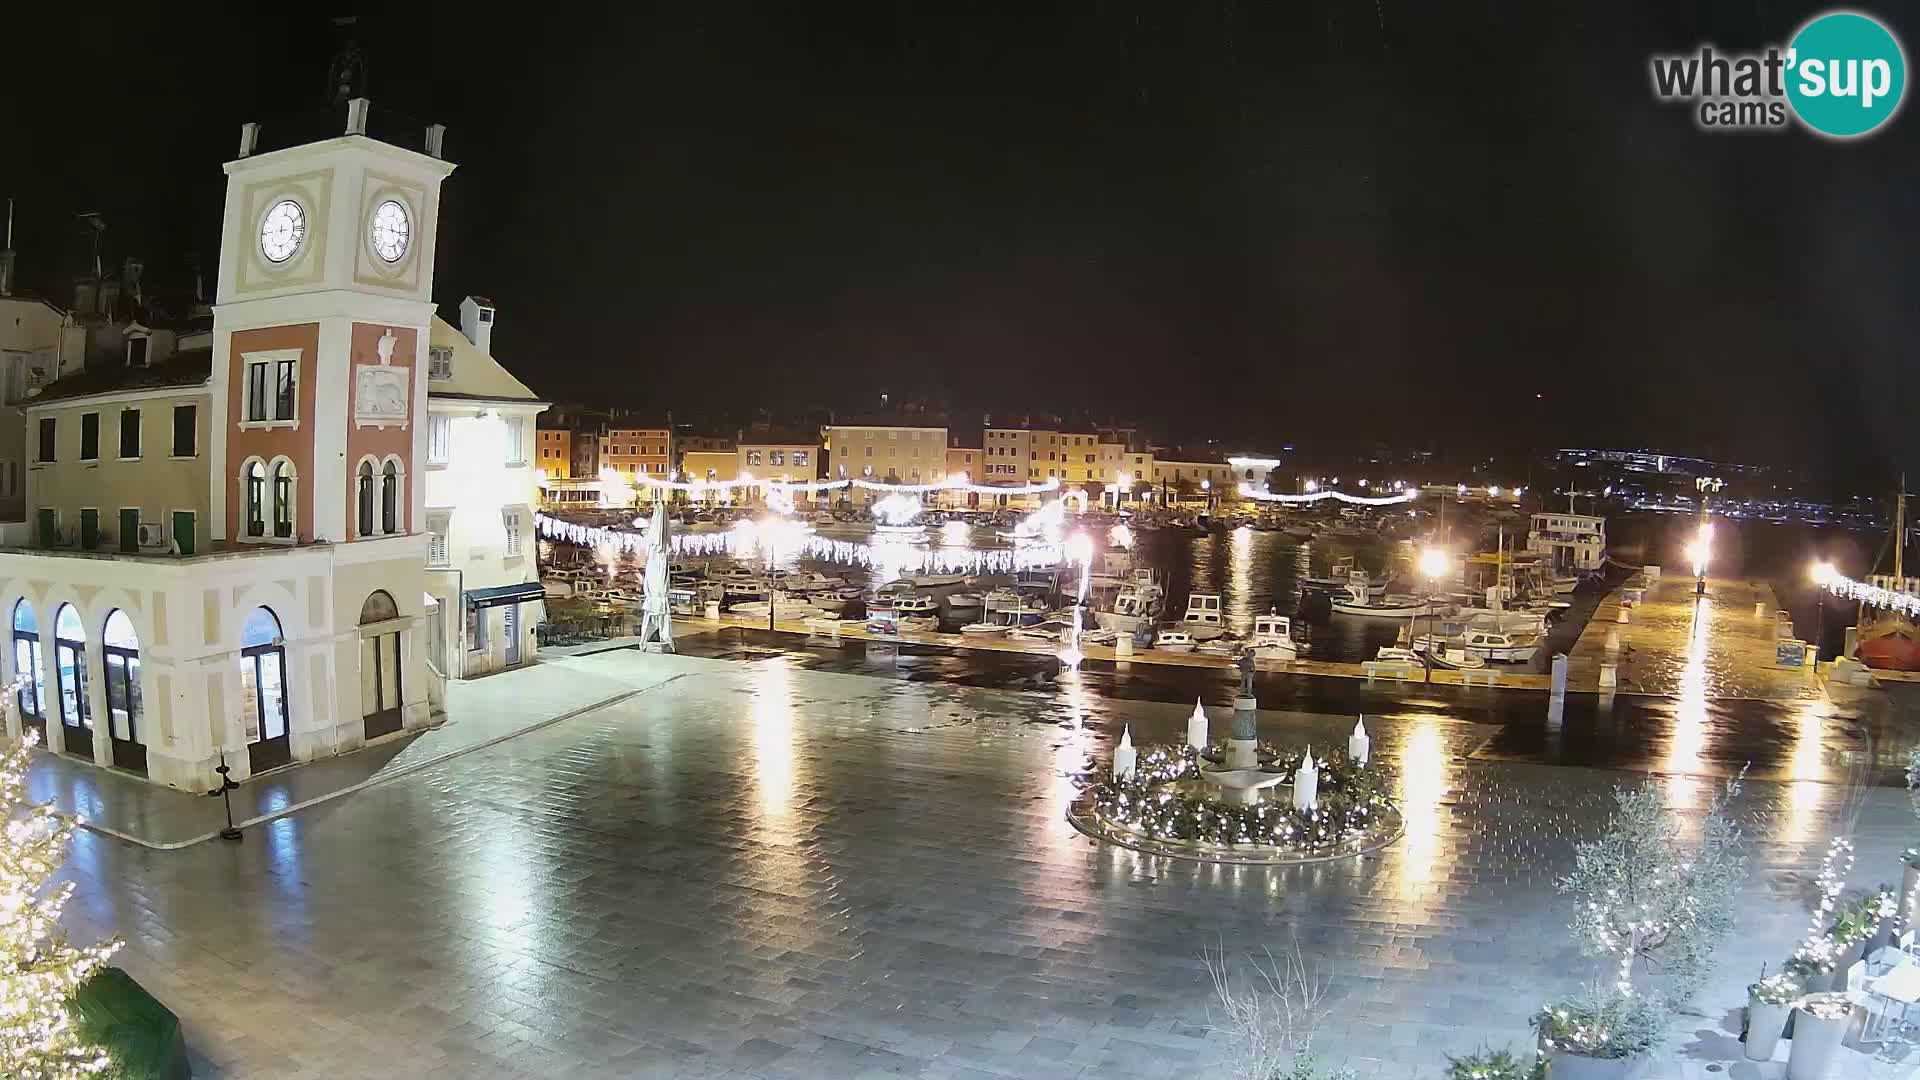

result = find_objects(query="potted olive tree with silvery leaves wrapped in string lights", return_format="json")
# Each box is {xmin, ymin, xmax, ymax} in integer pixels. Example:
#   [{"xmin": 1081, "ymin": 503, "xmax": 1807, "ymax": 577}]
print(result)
[{"xmin": 1534, "ymin": 776, "xmax": 1747, "ymax": 1080}]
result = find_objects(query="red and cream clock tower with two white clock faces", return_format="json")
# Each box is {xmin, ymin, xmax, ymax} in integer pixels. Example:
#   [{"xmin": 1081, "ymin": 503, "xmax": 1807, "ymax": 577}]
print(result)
[{"xmin": 209, "ymin": 98, "xmax": 453, "ymax": 544}]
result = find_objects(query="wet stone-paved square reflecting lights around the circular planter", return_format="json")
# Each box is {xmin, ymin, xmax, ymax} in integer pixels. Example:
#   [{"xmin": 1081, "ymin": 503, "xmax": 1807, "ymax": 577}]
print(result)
[{"xmin": 56, "ymin": 651, "xmax": 1914, "ymax": 1080}]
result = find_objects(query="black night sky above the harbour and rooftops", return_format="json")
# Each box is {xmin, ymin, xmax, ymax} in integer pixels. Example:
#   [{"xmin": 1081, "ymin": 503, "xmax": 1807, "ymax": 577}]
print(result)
[{"xmin": 0, "ymin": 0, "xmax": 1920, "ymax": 486}]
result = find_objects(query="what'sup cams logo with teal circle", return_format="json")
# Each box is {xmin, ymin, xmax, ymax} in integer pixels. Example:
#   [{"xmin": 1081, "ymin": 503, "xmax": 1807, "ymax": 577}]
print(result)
[{"xmin": 1649, "ymin": 12, "xmax": 1907, "ymax": 138}]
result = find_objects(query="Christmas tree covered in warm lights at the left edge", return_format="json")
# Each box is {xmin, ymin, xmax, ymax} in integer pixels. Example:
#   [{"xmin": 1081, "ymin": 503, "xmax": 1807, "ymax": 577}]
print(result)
[{"xmin": 0, "ymin": 722, "xmax": 121, "ymax": 1080}]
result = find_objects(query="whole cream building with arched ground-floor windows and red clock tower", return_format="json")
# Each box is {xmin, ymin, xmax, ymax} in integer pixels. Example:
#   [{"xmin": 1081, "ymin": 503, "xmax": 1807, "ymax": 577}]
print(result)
[{"xmin": 0, "ymin": 98, "xmax": 453, "ymax": 792}]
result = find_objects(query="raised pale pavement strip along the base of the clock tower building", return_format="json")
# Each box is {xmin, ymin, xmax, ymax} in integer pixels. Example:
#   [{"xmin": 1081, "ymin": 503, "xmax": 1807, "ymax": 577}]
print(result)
[{"xmin": 27, "ymin": 657, "xmax": 718, "ymax": 849}]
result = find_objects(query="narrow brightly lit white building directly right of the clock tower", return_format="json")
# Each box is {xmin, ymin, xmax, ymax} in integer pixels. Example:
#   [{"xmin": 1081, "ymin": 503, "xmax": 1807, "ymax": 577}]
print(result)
[{"xmin": 424, "ymin": 296, "xmax": 547, "ymax": 676}]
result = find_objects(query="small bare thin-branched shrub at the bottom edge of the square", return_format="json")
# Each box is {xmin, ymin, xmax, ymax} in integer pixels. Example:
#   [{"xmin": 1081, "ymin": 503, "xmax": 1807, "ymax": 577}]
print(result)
[{"xmin": 1200, "ymin": 944, "xmax": 1354, "ymax": 1080}]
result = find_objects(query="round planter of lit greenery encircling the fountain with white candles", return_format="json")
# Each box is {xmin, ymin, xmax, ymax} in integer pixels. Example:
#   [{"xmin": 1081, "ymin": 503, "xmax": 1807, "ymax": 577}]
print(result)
[{"xmin": 1068, "ymin": 744, "xmax": 1404, "ymax": 867}]
